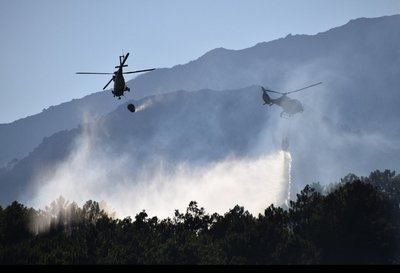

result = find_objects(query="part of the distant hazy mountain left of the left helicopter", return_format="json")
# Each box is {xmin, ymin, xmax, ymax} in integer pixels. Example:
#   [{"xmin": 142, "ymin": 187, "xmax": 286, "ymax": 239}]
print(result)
[{"xmin": 0, "ymin": 92, "xmax": 123, "ymax": 166}]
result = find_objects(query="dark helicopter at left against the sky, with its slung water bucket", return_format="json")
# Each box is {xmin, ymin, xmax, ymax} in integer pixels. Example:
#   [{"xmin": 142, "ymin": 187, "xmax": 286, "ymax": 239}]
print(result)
[{"xmin": 76, "ymin": 52, "xmax": 155, "ymax": 112}]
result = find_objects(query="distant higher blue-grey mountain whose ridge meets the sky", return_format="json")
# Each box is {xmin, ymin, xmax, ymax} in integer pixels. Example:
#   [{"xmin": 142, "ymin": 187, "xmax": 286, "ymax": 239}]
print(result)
[{"xmin": 0, "ymin": 15, "xmax": 400, "ymax": 166}]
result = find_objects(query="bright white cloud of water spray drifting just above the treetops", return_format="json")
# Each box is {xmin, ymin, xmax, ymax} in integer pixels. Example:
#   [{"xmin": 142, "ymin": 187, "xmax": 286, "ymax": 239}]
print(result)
[{"xmin": 29, "ymin": 119, "xmax": 288, "ymax": 217}]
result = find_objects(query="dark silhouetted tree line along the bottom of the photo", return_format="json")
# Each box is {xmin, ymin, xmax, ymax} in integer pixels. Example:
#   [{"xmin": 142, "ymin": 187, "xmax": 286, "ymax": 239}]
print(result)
[{"xmin": 0, "ymin": 170, "xmax": 400, "ymax": 264}]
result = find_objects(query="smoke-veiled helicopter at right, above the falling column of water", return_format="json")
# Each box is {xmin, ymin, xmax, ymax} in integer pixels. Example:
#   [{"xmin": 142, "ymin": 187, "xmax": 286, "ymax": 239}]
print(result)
[{"xmin": 261, "ymin": 82, "xmax": 322, "ymax": 117}]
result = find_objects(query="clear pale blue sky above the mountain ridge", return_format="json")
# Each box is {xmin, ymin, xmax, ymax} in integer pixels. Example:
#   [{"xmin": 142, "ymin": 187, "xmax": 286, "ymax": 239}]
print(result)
[{"xmin": 0, "ymin": 0, "xmax": 400, "ymax": 123}]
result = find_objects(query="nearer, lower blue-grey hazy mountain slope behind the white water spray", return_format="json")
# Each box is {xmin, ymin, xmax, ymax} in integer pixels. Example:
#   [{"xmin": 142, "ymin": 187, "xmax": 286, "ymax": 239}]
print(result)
[{"xmin": 0, "ymin": 83, "xmax": 400, "ymax": 204}]
